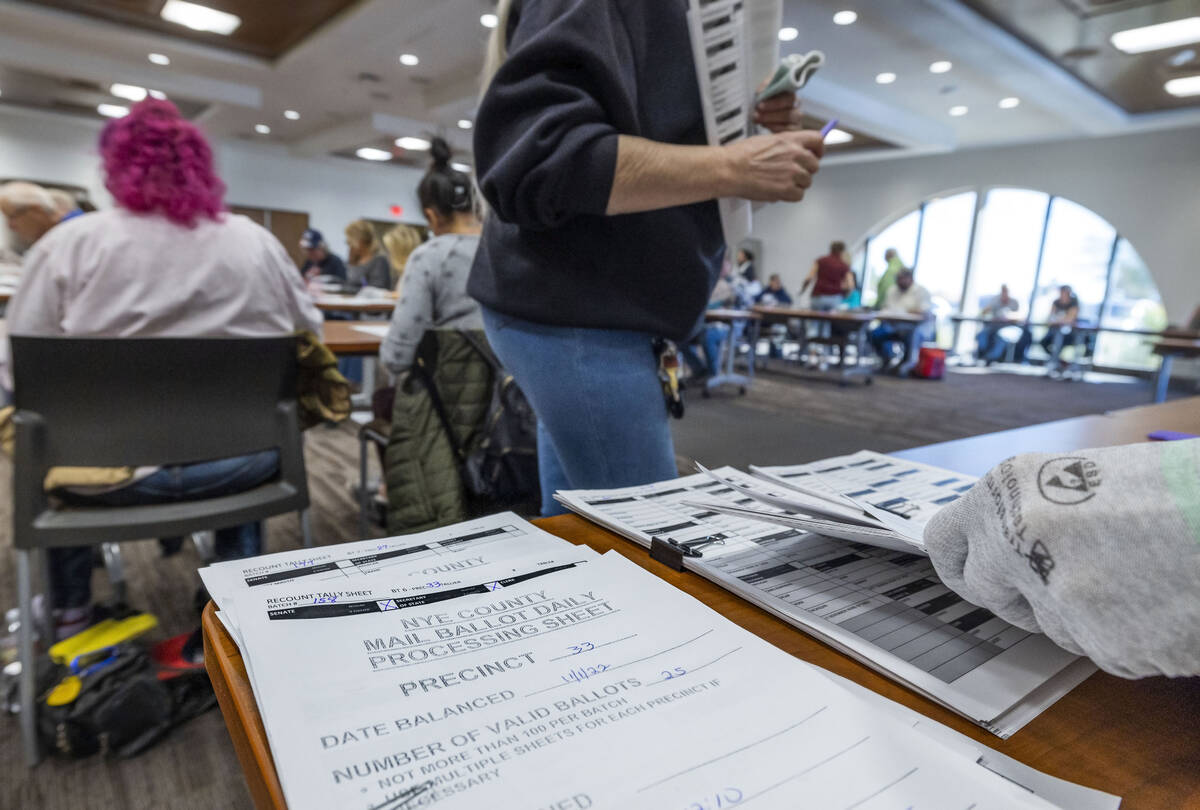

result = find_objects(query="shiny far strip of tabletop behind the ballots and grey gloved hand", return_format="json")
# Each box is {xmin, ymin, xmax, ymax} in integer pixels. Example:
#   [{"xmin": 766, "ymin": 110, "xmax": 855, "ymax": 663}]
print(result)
[{"xmin": 892, "ymin": 397, "xmax": 1200, "ymax": 475}]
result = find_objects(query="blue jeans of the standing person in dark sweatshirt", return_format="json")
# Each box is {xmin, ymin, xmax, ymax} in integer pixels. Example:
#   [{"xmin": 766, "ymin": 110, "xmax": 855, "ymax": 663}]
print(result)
[{"xmin": 482, "ymin": 308, "xmax": 677, "ymax": 517}]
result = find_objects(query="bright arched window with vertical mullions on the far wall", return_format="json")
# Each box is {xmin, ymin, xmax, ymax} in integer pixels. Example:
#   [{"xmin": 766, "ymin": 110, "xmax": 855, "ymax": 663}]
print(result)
[{"xmin": 853, "ymin": 188, "xmax": 1166, "ymax": 368}]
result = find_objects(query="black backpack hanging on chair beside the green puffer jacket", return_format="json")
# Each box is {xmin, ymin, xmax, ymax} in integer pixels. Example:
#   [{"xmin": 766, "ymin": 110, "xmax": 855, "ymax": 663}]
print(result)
[{"xmin": 414, "ymin": 331, "xmax": 540, "ymax": 505}]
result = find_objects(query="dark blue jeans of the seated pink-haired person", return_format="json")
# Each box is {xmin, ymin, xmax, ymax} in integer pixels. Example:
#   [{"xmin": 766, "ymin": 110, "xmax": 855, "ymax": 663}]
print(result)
[{"xmin": 49, "ymin": 450, "xmax": 280, "ymax": 608}]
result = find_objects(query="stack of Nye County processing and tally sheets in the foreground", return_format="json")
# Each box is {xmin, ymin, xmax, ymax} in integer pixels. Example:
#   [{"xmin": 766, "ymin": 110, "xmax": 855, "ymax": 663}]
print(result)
[{"xmin": 202, "ymin": 514, "xmax": 1116, "ymax": 810}]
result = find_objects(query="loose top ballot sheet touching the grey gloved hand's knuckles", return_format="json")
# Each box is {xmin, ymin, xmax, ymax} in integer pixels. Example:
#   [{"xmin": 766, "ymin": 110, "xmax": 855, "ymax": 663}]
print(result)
[{"xmin": 750, "ymin": 450, "xmax": 979, "ymax": 546}]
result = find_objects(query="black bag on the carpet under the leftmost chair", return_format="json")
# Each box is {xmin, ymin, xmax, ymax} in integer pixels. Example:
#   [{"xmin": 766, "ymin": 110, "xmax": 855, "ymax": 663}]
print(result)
[{"xmin": 37, "ymin": 644, "xmax": 216, "ymax": 758}]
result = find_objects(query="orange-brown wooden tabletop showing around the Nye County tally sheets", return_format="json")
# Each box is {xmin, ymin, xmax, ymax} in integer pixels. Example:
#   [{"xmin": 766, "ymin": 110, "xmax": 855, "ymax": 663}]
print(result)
[{"xmin": 203, "ymin": 515, "xmax": 1200, "ymax": 810}]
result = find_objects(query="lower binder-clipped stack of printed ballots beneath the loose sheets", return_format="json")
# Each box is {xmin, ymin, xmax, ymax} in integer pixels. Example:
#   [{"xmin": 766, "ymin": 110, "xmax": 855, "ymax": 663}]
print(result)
[{"xmin": 556, "ymin": 467, "xmax": 1096, "ymax": 737}]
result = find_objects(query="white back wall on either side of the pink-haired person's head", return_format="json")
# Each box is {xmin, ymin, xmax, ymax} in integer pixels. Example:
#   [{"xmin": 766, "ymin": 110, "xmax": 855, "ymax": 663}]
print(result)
[{"xmin": 0, "ymin": 106, "xmax": 422, "ymax": 256}]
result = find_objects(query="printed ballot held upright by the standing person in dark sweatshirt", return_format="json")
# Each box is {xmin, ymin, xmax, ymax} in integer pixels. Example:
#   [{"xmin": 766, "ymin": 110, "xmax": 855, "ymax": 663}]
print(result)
[{"xmin": 688, "ymin": 0, "xmax": 754, "ymax": 246}]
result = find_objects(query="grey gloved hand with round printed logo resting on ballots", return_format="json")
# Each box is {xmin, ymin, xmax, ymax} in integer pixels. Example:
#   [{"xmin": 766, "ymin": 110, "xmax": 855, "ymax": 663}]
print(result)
[{"xmin": 925, "ymin": 439, "xmax": 1200, "ymax": 678}]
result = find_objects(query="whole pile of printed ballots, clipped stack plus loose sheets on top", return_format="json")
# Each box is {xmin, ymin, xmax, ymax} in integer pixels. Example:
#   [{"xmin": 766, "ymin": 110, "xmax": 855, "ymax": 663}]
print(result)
[{"xmin": 556, "ymin": 463, "xmax": 1096, "ymax": 737}]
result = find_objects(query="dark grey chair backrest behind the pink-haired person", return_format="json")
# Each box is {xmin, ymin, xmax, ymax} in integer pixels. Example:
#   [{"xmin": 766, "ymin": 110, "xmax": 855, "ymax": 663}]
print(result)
[{"xmin": 11, "ymin": 335, "xmax": 296, "ymax": 467}]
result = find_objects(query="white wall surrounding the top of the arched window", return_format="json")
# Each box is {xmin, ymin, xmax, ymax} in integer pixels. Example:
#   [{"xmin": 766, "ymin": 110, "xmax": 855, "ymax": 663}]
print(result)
[{"xmin": 754, "ymin": 128, "xmax": 1200, "ymax": 322}]
